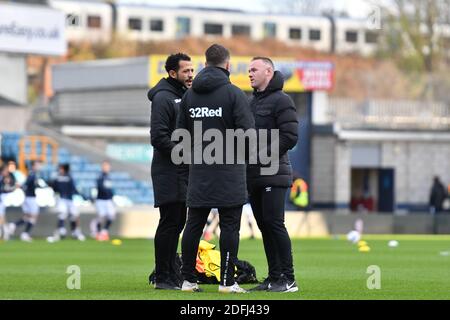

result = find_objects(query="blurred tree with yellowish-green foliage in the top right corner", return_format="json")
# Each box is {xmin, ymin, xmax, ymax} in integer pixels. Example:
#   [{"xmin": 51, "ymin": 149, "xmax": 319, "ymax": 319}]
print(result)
[{"xmin": 370, "ymin": 0, "xmax": 450, "ymax": 99}]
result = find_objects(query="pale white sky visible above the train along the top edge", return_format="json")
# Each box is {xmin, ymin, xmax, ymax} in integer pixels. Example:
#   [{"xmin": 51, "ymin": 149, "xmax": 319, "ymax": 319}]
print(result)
[{"xmin": 119, "ymin": 0, "xmax": 370, "ymax": 18}]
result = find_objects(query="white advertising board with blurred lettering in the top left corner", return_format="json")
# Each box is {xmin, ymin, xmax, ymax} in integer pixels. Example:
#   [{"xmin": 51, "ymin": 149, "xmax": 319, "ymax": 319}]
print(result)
[{"xmin": 0, "ymin": 3, "xmax": 67, "ymax": 56}]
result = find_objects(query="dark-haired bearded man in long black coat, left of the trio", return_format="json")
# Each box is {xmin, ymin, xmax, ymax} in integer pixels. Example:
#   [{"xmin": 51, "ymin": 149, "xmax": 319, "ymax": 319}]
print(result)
[{"xmin": 148, "ymin": 53, "xmax": 194, "ymax": 290}]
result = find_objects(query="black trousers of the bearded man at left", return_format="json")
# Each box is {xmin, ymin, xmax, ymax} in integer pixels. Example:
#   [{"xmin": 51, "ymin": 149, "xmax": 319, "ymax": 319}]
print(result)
[{"xmin": 155, "ymin": 202, "xmax": 186, "ymax": 282}]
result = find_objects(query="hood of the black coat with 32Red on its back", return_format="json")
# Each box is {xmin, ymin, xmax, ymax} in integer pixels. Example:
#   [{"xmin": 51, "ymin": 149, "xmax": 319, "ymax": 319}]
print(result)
[{"xmin": 192, "ymin": 67, "xmax": 230, "ymax": 93}]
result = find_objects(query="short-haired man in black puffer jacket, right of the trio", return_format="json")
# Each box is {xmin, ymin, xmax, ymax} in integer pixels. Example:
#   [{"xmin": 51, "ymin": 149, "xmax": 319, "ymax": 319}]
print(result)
[{"xmin": 247, "ymin": 57, "xmax": 298, "ymax": 292}]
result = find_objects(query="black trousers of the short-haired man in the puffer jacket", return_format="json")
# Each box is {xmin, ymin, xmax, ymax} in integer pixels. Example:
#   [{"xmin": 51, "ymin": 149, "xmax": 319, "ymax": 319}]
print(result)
[{"xmin": 249, "ymin": 187, "xmax": 295, "ymax": 281}]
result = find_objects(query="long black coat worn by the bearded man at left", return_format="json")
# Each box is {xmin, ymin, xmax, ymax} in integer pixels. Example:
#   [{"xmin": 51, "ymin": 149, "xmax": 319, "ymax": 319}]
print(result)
[{"xmin": 148, "ymin": 79, "xmax": 189, "ymax": 207}]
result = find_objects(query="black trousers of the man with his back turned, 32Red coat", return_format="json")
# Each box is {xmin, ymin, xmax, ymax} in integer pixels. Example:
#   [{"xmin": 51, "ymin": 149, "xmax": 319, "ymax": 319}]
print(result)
[{"xmin": 181, "ymin": 206, "xmax": 242, "ymax": 286}]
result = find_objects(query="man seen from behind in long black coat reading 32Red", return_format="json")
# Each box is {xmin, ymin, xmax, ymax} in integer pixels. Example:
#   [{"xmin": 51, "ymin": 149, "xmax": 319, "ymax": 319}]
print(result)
[{"xmin": 177, "ymin": 44, "xmax": 254, "ymax": 293}]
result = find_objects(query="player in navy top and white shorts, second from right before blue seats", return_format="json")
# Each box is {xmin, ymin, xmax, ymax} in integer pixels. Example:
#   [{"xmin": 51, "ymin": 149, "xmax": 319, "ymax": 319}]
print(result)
[{"xmin": 50, "ymin": 164, "xmax": 85, "ymax": 241}]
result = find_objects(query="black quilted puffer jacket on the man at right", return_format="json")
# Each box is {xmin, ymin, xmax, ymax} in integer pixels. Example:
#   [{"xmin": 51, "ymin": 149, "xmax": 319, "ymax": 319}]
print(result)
[{"xmin": 247, "ymin": 71, "xmax": 298, "ymax": 191}]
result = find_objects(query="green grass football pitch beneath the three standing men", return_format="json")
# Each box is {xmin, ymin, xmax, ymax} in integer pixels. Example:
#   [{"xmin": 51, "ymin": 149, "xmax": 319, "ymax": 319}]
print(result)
[{"xmin": 0, "ymin": 236, "xmax": 450, "ymax": 300}]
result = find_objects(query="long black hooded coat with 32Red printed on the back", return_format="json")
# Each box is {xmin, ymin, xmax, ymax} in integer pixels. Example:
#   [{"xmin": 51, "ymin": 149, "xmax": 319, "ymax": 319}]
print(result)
[{"xmin": 177, "ymin": 67, "xmax": 254, "ymax": 208}]
